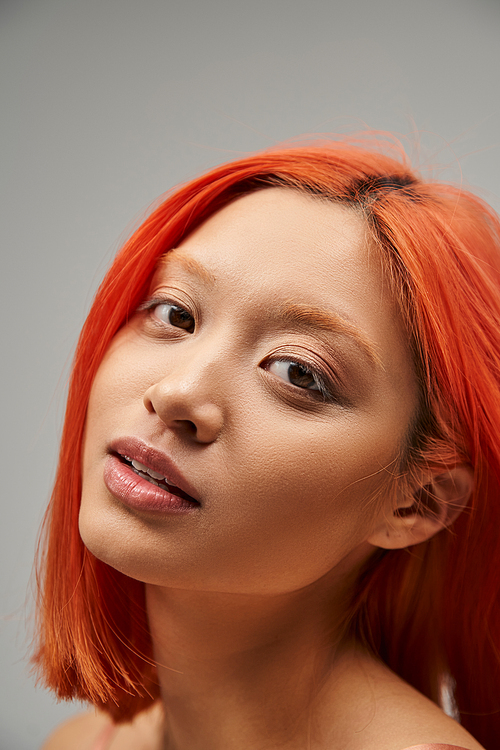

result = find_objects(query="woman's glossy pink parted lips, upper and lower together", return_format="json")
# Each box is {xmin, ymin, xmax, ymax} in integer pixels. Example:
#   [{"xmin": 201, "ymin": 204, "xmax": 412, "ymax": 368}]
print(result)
[{"xmin": 103, "ymin": 438, "xmax": 200, "ymax": 513}]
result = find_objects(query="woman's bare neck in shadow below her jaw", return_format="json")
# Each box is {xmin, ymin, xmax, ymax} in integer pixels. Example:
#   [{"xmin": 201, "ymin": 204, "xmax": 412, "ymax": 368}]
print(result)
[{"xmin": 147, "ymin": 568, "xmax": 362, "ymax": 750}]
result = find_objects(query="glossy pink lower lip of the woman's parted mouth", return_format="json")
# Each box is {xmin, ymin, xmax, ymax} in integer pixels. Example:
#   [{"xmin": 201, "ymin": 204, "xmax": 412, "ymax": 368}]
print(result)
[{"xmin": 104, "ymin": 456, "xmax": 200, "ymax": 514}]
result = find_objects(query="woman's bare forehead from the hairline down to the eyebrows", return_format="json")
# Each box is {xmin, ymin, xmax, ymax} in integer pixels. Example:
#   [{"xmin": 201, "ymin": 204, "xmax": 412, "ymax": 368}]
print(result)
[{"xmin": 154, "ymin": 188, "xmax": 411, "ymax": 390}]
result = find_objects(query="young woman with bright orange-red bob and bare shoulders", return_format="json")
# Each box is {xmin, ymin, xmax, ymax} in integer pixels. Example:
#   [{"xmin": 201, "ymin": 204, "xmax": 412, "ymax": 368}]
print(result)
[{"xmin": 35, "ymin": 137, "xmax": 500, "ymax": 750}]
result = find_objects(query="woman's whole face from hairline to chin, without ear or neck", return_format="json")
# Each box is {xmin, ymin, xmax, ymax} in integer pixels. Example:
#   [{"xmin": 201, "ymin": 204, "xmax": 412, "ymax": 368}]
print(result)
[{"xmin": 80, "ymin": 188, "xmax": 417, "ymax": 594}]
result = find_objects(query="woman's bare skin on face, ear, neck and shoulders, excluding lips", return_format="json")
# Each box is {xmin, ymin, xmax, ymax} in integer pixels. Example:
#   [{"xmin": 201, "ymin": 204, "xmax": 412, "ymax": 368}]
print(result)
[{"xmin": 46, "ymin": 188, "xmax": 480, "ymax": 750}]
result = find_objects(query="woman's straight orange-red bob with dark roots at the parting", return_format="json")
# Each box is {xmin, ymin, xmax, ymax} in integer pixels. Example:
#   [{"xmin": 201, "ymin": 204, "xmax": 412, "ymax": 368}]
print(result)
[{"xmin": 34, "ymin": 135, "xmax": 500, "ymax": 750}]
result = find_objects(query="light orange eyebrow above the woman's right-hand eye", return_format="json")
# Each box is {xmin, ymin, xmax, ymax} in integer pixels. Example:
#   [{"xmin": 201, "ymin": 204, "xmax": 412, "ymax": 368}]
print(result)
[{"xmin": 278, "ymin": 302, "xmax": 382, "ymax": 367}]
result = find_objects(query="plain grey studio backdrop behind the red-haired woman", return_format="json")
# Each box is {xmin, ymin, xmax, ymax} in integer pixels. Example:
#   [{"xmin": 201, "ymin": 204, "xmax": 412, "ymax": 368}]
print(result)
[{"xmin": 0, "ymin": 0, "xmax": 500, "ymax": 750}]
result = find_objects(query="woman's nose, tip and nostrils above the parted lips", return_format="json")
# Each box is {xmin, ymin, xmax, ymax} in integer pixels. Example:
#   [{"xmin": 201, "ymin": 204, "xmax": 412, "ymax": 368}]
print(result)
[{"xmin": 143, "ymin": 350, "xmax": 224, "ymax": 443}]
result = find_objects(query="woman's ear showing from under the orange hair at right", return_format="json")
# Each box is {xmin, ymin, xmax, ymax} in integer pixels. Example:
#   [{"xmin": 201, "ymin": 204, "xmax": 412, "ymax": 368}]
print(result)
[{"xmin": 367, "ymin": 464, "xmax": 474, "ymax": 549}]
